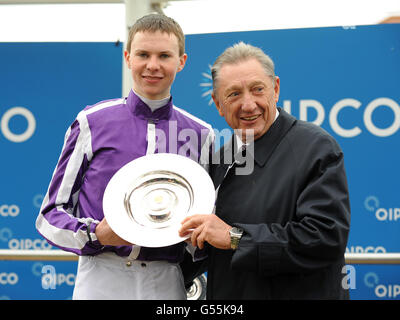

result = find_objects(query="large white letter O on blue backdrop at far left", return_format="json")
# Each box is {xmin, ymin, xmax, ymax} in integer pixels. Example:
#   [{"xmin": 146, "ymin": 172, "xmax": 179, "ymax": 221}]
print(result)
[{"xmin": 0, "ymin": 107, "xmax": 36, "ymax": 143}]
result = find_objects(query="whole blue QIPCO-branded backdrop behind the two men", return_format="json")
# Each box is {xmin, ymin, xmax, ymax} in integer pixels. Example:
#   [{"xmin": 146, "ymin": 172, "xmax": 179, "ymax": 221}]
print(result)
[{"xmin": 0, "ymin": 25, "xmax": 400, "ymax": 299}]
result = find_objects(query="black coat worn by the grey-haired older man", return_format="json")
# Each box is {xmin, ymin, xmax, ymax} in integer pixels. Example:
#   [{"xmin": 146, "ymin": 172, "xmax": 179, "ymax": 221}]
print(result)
[{"xmin": 207, "ymin": 109, "xmax": 350, "ymax": 299}]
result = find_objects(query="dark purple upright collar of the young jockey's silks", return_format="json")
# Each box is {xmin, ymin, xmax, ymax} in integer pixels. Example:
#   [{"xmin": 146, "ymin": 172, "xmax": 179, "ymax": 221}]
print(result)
[{"xmin": 126, "ymin": 90, "xmax": 173, "ymax": 122}]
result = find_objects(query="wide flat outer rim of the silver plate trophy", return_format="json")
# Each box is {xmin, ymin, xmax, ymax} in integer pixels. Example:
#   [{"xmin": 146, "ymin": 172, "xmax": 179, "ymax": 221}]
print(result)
[{"xmin": 103, "ymin": 153, "xmax": 215, "ymax": 247}]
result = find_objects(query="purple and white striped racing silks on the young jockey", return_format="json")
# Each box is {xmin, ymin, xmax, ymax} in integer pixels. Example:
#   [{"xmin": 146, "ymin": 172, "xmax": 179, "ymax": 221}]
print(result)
[{"xmin": 36, "ymin": 91, "xmax": 215, "ymax": 262}]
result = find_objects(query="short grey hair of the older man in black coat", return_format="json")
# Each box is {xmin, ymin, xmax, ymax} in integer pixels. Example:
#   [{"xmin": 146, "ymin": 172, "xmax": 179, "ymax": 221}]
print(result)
[{"xmin": 211, "ymin": 41, "xmax": 276, "ymax": 94}]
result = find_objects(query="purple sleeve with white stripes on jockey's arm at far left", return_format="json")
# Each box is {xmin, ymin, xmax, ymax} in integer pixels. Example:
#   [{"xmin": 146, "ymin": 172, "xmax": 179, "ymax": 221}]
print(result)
[{"xmin": 36, "ymin": 116, "xmax": 102, "ymax": 255}]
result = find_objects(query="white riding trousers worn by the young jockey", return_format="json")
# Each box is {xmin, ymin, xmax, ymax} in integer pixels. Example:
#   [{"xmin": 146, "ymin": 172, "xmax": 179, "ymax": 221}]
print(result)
[{"xmin": 72, "ymin": 252, "xmax": 186, "ymax": 300}]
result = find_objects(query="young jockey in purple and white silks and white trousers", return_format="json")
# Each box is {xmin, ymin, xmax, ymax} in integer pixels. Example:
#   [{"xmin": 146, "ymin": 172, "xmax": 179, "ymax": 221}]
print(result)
[{"xmin": 36, "ymin": 14, "xmax": 214, "ymax": 299}]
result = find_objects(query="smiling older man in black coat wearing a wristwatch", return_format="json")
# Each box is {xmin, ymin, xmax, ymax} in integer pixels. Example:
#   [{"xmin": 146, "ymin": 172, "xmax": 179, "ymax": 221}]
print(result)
[{"xmin": 180, "ymin": 43, "xmax": 350, "ymax": 299}]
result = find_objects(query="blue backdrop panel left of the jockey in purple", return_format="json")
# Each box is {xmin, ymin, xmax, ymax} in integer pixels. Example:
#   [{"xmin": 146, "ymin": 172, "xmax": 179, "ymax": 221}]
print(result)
[{"xmin": 0, "ymin": 43, "xmax": 122, "ymax": 299}]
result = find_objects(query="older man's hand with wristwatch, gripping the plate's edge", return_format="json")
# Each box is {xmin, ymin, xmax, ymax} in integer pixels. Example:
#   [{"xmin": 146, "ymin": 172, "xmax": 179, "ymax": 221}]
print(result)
[{"xmin": 179, "ymin": 214, "xmax": 232, "ymax": 249}]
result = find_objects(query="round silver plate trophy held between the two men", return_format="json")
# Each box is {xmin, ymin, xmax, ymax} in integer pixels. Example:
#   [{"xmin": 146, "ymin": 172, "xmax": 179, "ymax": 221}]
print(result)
[{"xmin": 103, "ymin": 153, "xmax": 215, "ymax": 247}]
